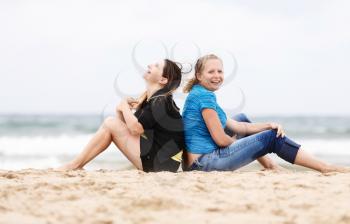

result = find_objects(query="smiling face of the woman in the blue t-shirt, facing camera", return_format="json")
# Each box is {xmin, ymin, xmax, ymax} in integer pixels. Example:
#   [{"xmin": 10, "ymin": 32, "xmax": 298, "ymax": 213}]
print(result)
[{"xmin": 197, "ymin": 59, "xmax": 224, "ymax": 91}]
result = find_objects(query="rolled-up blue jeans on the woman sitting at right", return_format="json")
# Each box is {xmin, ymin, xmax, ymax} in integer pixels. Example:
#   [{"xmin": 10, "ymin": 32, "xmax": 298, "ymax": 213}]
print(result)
[{"xmin": 187, "ymin": 113, "xmax": 300, "ymax": 171}]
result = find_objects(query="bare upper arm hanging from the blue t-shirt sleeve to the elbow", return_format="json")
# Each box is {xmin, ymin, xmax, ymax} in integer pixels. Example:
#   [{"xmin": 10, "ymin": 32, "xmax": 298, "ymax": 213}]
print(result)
[{"xmin": 202, "ymin": 108, "xmax": 234, "ymax": 147}]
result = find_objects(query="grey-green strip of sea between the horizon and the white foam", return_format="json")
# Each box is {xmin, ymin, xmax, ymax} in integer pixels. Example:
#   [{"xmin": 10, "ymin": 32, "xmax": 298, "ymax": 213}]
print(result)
[{"xmin": 0, "ymin": 115, "xmax": 350, "ymax": 138}]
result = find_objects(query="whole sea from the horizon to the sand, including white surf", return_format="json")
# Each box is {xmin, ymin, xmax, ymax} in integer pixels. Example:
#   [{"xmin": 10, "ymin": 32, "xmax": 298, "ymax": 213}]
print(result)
[{"xmin": 0, "ymin": 114, "xmax": 350, "ymax": 170}]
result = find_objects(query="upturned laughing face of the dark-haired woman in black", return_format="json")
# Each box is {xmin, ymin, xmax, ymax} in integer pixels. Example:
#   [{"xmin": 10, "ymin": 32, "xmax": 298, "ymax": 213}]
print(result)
[{"xmin": 143, "ymin": 60, "xmax": 167, "ymax": 86}]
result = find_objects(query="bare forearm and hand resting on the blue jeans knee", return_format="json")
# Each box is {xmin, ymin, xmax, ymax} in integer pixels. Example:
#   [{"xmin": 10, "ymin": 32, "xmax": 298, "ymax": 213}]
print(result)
[{"xmin": 226, "ymin": 118, "xmax": 285, "ymax": 137}]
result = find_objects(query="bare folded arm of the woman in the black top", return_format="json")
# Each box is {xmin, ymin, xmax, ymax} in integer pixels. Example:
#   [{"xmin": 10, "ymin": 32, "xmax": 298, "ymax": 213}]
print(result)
[{"xmin": 117, "ymin": 99, "xmax": 144, "ymax": 135}]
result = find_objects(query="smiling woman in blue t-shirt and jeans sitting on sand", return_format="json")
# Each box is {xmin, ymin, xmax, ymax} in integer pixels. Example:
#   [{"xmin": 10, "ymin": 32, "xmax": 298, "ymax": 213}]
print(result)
[{"xmin": 182, "ymin": 54, "xmax": 349, "ymax": 172}]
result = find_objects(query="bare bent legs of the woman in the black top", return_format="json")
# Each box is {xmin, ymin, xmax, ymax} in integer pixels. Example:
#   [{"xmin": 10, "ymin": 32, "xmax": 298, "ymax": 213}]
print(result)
[{"xmin": 58, "ymin": 116, "xmax": 142, "ymax": 170}]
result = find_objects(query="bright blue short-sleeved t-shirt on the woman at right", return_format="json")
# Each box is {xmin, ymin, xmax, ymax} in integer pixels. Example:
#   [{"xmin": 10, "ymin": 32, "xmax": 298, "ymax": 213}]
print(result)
[{"xmin": 182, "ymin": 84, "xmax": 227, "ymax": 154}]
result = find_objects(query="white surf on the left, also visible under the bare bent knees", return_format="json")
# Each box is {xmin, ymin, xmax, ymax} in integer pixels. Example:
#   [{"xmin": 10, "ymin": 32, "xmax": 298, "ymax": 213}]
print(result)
[{"xmin": 0, "ymin": 134, "xmax": 129, "ymax": 170}]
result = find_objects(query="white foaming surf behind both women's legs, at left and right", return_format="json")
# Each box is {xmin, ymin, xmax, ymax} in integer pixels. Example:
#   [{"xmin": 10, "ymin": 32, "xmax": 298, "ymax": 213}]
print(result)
[{"xmin": 0, "ymin": 134, "xmax": 350, "ymax": 170}]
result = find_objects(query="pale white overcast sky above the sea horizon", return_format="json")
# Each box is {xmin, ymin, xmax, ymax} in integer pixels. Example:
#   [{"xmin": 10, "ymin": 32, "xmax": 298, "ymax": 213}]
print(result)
[{"xmin": 0, "ymin": 0, "xmax": 350, "ymax": 115}]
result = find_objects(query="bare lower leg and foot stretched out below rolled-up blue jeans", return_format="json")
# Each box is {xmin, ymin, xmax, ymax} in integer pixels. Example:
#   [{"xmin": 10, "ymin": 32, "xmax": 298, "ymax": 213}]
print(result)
[{"xmin": 294, "ymin": 148, "xmax": 350, "ymax": 173}]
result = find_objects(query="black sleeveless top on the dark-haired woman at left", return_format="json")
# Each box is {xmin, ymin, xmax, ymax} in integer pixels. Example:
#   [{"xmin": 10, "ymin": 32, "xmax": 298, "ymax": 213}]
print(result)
[{"xmin": 134, "ymin": 89, "xmax": 185, "ymax": 172}]
